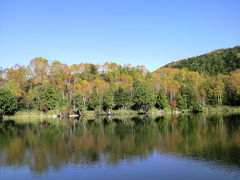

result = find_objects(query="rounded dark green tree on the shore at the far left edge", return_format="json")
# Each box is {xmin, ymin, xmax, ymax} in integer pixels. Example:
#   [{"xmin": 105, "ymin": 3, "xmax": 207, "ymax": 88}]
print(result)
[{"xmin": 0, "ymin": 88, "xmax": 18, "ymax": 116}]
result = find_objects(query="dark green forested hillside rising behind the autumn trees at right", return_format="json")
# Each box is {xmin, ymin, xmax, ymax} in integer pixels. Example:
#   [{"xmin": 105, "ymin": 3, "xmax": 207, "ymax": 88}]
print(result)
[{"xmin": 161, "ymin": 46, "xmax": 240, "ymax": 75}]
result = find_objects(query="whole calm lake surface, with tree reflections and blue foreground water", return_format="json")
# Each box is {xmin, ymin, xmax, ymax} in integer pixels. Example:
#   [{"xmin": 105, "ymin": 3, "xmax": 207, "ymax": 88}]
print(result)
[{"xmin": 0, "ymin": 114, "xmax": 240, "ymax": 180}]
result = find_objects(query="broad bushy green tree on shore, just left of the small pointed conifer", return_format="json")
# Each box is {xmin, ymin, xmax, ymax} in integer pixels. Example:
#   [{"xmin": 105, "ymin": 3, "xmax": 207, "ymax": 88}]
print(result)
[{"xmin": 133, "ymin": 81, "xmax": 155, "ymax": 111}]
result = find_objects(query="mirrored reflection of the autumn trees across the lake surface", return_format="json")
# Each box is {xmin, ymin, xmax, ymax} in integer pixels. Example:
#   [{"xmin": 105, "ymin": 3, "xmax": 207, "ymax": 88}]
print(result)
[{"xmin": 0, "ymin": 114, "xmax": 240, "ymax": 172}]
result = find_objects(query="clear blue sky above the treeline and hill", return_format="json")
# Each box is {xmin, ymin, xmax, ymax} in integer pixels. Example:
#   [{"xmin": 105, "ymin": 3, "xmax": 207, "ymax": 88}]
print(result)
[{"xmin": 0, "ymin": 0, "xmax": 240, "ymax": 70}]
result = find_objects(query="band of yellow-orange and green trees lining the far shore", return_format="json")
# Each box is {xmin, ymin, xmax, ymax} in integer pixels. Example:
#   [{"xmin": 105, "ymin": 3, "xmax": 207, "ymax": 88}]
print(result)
[{"xmin": 0, "ymin": 47, "xmax": 240, "ymax": 116}]
